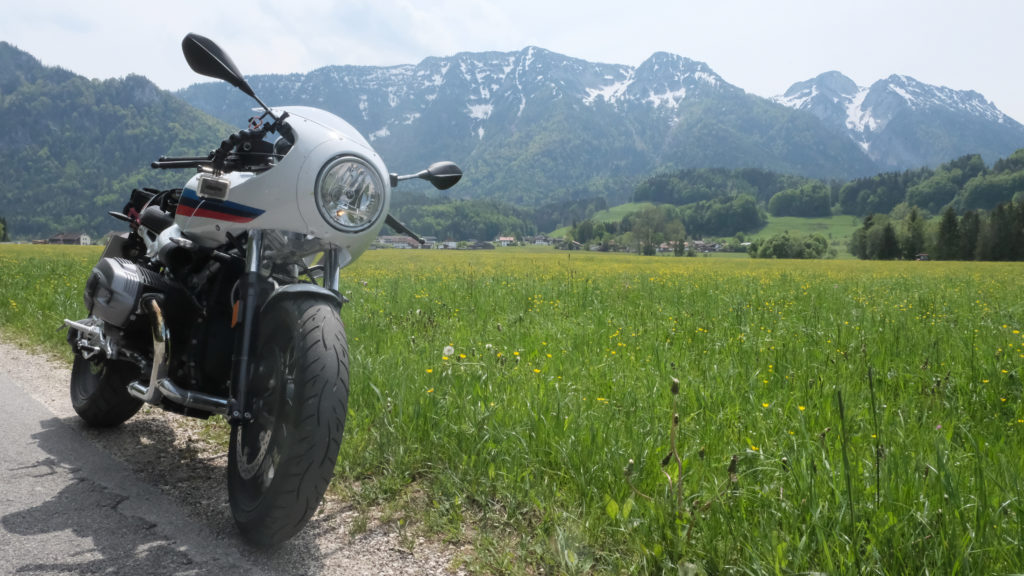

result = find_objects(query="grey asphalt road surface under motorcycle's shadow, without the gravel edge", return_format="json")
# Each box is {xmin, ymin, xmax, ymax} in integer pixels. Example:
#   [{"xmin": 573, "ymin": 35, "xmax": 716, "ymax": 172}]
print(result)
[{"xmin": 0, "ymin": 373, "xmax": 278, "ymax": 576}]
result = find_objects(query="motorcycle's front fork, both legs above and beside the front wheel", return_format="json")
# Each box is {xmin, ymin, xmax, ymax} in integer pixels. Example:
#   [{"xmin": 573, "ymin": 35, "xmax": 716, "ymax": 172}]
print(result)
[{"xmin": 227, "ymin": 230, "xmax": 341, "ymax": 424}]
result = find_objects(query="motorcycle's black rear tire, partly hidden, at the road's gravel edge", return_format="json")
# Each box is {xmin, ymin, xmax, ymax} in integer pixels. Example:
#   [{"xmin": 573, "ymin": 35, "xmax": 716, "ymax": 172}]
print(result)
[{"xmin": 71, "ymin": 355, "xmax": 142, "ymax": 427}]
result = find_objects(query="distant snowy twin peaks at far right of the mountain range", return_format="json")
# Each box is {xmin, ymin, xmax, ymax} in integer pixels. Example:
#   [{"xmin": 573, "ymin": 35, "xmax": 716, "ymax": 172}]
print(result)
[{"xmin": 773, "ymin": 72, "xmax": 1024, "ymax": 168}]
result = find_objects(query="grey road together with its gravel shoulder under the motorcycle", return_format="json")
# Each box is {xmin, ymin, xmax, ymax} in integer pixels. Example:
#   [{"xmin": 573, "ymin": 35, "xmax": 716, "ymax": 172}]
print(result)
[{"xmin": 0, "ymin": 334, "xmax": 464, "ymax": 576}]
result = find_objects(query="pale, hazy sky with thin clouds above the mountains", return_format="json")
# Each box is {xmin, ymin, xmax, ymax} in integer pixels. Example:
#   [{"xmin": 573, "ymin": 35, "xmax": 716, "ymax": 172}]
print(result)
[{"xmin": 0, "ymin": 0, "xmax": 1024, "ymax": 122}]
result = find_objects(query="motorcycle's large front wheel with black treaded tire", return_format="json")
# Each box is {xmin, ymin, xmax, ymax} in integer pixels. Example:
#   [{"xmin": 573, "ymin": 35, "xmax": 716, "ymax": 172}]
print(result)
[{"xmin": 227, "ymin": 297, "xmax": 348, "ymax": 546}]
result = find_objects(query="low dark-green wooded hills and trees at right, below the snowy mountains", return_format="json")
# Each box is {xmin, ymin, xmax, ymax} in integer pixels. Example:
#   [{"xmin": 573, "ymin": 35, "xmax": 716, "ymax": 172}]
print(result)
[{"xmin": 569, "ymin": 150, "xmax": 1024, "ymax": 254}]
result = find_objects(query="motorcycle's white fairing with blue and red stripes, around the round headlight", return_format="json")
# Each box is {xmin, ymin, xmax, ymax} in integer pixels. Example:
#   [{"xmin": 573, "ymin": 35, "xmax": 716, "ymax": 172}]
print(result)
[{"xmin": 174, "ymin": 107, "xmax": 391, "ymax": 262}]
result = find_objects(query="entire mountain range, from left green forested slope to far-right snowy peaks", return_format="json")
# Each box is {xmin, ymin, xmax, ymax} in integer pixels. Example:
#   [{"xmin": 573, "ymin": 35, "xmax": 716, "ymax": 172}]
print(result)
[{"xmin": 0, "ymin": 42, "xmax": 1024, "ymax": 236}]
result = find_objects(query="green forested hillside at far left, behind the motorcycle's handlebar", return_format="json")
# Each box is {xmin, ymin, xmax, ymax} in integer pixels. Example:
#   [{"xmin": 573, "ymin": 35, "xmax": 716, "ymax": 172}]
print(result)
[{"xmin": 0, "ymin": 42, "xmax": 230, "ymax": 240}]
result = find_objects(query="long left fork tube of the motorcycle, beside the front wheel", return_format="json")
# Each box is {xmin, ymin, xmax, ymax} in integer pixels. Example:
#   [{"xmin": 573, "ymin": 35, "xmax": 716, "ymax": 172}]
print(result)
[{"xmin": 230, "ymin": 230, "xmax": 263, "ymax": 423}]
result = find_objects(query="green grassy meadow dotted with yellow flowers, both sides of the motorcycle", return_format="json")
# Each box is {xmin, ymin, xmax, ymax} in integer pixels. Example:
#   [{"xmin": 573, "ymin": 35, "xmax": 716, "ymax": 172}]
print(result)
[{"xmin": 0, "ymin": 242, "xmax": 1024, "ymax": 574}]
